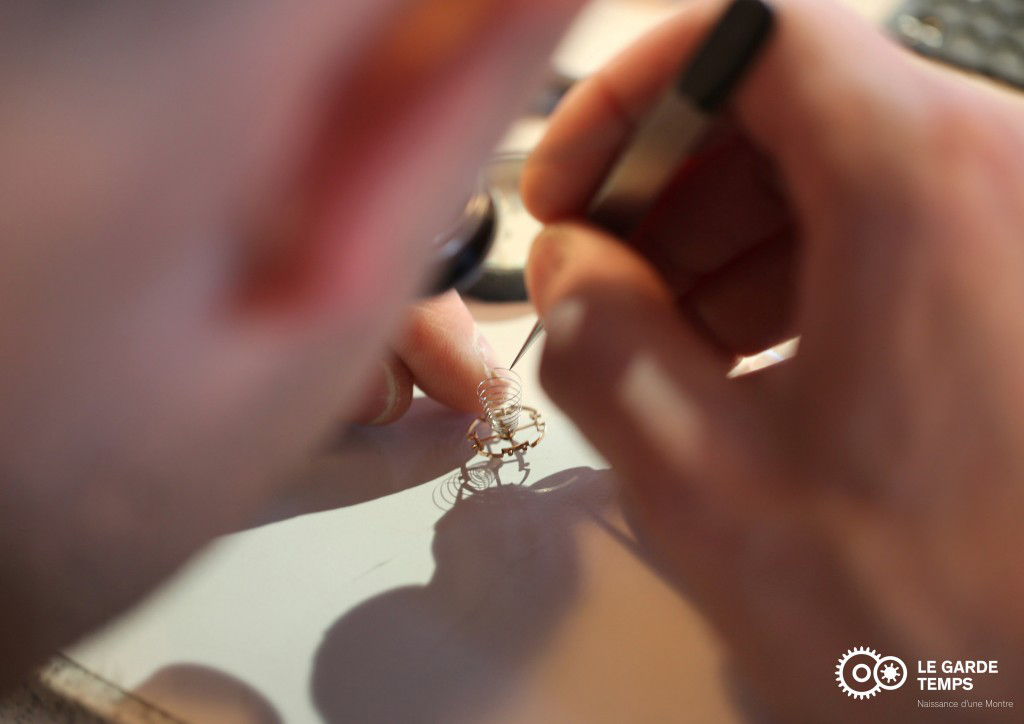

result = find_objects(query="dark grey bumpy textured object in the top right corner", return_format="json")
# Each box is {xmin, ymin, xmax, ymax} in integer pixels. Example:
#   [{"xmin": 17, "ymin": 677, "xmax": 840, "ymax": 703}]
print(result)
[{"xmin": 888, "ymin": 0, "xmax": 1024, "ymax": 88}]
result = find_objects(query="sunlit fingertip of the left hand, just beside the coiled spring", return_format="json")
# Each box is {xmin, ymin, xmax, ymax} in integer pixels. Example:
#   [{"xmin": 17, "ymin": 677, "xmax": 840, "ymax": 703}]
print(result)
[{"xmin": 395, "ymin": 292, "xmax": 496, "ymax": 412}]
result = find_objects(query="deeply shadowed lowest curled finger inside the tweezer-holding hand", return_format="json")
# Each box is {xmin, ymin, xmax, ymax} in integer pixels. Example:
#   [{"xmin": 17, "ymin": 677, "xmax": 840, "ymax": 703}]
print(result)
[{"xmin": 680, "ymin": 231, "xmax": 797, "ymax": 356}]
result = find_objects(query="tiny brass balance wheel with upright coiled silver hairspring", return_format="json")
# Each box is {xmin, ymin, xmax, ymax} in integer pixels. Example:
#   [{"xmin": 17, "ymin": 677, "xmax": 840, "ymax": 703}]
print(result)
[{"xmin": 466, "ymin": 370, "xmax": 545, "ymax": 459}]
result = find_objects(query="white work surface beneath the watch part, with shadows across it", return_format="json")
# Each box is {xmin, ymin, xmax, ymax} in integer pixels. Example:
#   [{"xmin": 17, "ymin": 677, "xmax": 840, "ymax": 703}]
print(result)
[{"xmin": 58, "ymin": 0, "xmax": 888, "ymax": 724}]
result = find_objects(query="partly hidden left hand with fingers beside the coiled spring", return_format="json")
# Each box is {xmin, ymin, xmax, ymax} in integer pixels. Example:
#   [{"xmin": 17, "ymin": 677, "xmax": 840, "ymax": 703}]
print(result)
[{"xmin": 354, "ymin": 292, "xmax": 497, "ymax": 425}]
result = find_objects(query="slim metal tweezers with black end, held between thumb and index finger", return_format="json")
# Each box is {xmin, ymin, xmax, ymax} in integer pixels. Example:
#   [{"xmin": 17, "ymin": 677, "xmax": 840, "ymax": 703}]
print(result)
[{"xmin": 509, "ymin": 0, "xmax": 773, "ymax": 369}]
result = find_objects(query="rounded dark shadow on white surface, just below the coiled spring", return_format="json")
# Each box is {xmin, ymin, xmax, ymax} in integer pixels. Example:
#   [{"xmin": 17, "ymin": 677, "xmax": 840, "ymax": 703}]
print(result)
[{"xmin": 311, "ymin": 468, "xmax": 612, "ymax": 724}]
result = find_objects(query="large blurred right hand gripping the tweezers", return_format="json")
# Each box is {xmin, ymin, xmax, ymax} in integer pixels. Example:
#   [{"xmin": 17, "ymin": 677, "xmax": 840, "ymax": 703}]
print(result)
[{"xmin": 523, "ymin": 1, "xmax": 1024, "ymax": 721}]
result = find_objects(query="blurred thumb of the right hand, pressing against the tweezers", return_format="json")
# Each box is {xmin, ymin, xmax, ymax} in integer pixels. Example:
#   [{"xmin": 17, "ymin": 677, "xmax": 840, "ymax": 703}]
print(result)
[{"xmin": 527, "ymin": 224, "xmax": 761, "ymax": 507}]
